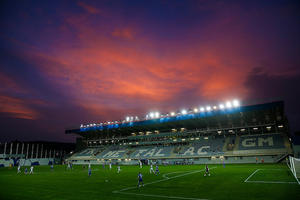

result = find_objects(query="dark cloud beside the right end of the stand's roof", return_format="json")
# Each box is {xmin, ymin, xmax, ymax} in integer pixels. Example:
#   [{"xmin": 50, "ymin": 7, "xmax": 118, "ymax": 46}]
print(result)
[{"xmin": 245, "ymin": 66, "xmax": 300, "ymax": 132}]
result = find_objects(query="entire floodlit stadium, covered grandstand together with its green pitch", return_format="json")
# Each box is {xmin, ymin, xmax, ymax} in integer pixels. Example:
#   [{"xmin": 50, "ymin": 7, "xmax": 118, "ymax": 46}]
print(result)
[{"xmin": 1, "ymin": 100, "xmax": 300, "ymax": 200}]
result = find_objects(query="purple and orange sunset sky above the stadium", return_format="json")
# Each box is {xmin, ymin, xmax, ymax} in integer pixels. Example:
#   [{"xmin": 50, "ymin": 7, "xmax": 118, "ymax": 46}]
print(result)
[{"xmin": 0, "ymin": 0, "xmax": 300, "ymax": 142}]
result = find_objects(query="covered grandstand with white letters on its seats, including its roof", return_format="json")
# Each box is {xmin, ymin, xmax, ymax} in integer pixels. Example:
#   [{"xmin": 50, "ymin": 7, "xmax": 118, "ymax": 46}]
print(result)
[{"xmin": 66, "ymin": 101, "xmax": 293, "ymax": 165}]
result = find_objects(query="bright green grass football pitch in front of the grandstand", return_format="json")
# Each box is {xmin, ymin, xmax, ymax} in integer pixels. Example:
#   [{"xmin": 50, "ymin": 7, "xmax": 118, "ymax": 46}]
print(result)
[{"xmin": 0, "ymin": 164, "xmax": 300, "ymax": 200}]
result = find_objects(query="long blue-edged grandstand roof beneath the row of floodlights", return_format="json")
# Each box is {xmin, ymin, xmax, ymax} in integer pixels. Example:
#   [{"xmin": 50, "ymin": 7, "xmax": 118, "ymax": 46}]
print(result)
[{"xmin": 65, "ymin": 101, "xmax": 285, "ymax": 136}]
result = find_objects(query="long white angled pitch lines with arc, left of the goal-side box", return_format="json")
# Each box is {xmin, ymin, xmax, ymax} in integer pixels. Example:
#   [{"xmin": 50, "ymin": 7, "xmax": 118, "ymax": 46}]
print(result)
[{"xmin": 113, "ymin": 167, "xmax": 217, "ymax": 200}]
